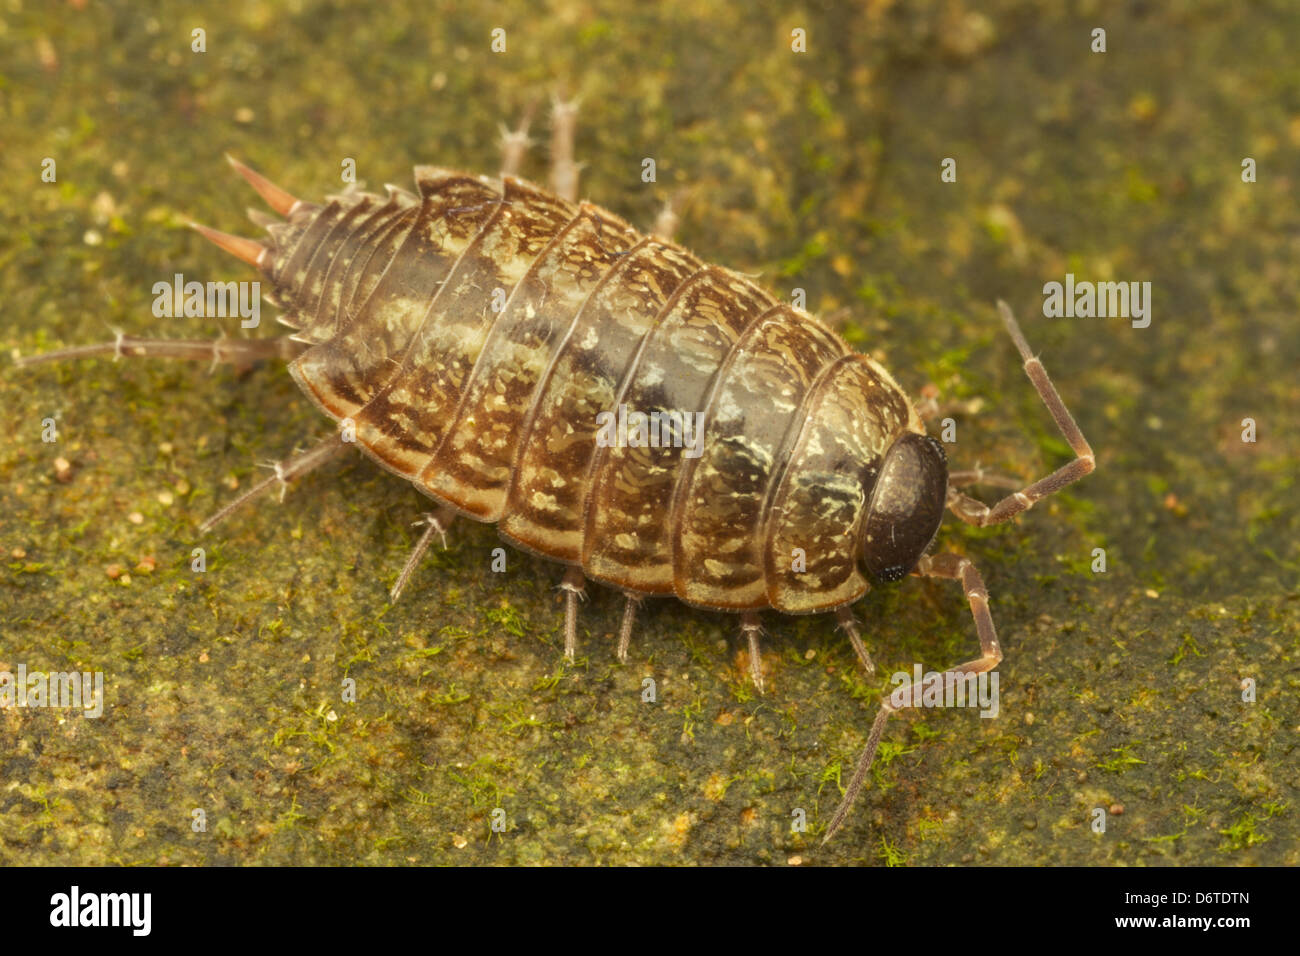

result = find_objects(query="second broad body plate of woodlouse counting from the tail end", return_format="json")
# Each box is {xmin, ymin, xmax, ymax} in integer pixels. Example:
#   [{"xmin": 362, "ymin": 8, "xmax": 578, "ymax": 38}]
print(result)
[{"xmin": 356, "ymin": 177, "xmax": 577, "ymax": 477}]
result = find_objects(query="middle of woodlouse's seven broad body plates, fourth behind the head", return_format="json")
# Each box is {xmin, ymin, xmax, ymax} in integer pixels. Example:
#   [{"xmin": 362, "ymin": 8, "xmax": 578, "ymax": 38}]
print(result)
[{"xmin": 501, "ymin": 238, "xmax": 701, "ymax": 563}]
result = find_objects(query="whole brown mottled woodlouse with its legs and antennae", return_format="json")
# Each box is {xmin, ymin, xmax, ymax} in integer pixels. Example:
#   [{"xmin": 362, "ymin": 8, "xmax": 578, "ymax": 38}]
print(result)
[{"xmin": 21, "ymin": 104, "xmax": 1095, "ymax": 839}]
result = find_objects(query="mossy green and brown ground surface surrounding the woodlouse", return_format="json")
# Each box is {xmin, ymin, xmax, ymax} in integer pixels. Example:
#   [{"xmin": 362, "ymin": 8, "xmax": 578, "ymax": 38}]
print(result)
[{"xmin": 0, "ymin": 0, "xmax": 1300, "ymax": 865}]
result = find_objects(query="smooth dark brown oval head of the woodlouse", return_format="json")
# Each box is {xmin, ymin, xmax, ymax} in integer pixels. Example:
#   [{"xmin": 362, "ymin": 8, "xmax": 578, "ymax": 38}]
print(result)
[{"xmin": 862, "ymin": 432, "xmax": 948, "ymax": 583}]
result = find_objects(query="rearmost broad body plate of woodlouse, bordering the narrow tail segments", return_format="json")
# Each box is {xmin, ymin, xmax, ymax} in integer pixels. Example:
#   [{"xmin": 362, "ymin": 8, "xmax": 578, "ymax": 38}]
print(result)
[{"xmin": 290, "ymin": 166, "xmax": 501, "ymax": 419}]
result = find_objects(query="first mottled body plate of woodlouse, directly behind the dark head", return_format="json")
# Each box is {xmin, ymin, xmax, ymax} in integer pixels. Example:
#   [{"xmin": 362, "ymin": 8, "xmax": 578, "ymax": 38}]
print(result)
[{"xmin": 759, "ymin": 354, "xmax": 923, "ymax": 614}]
